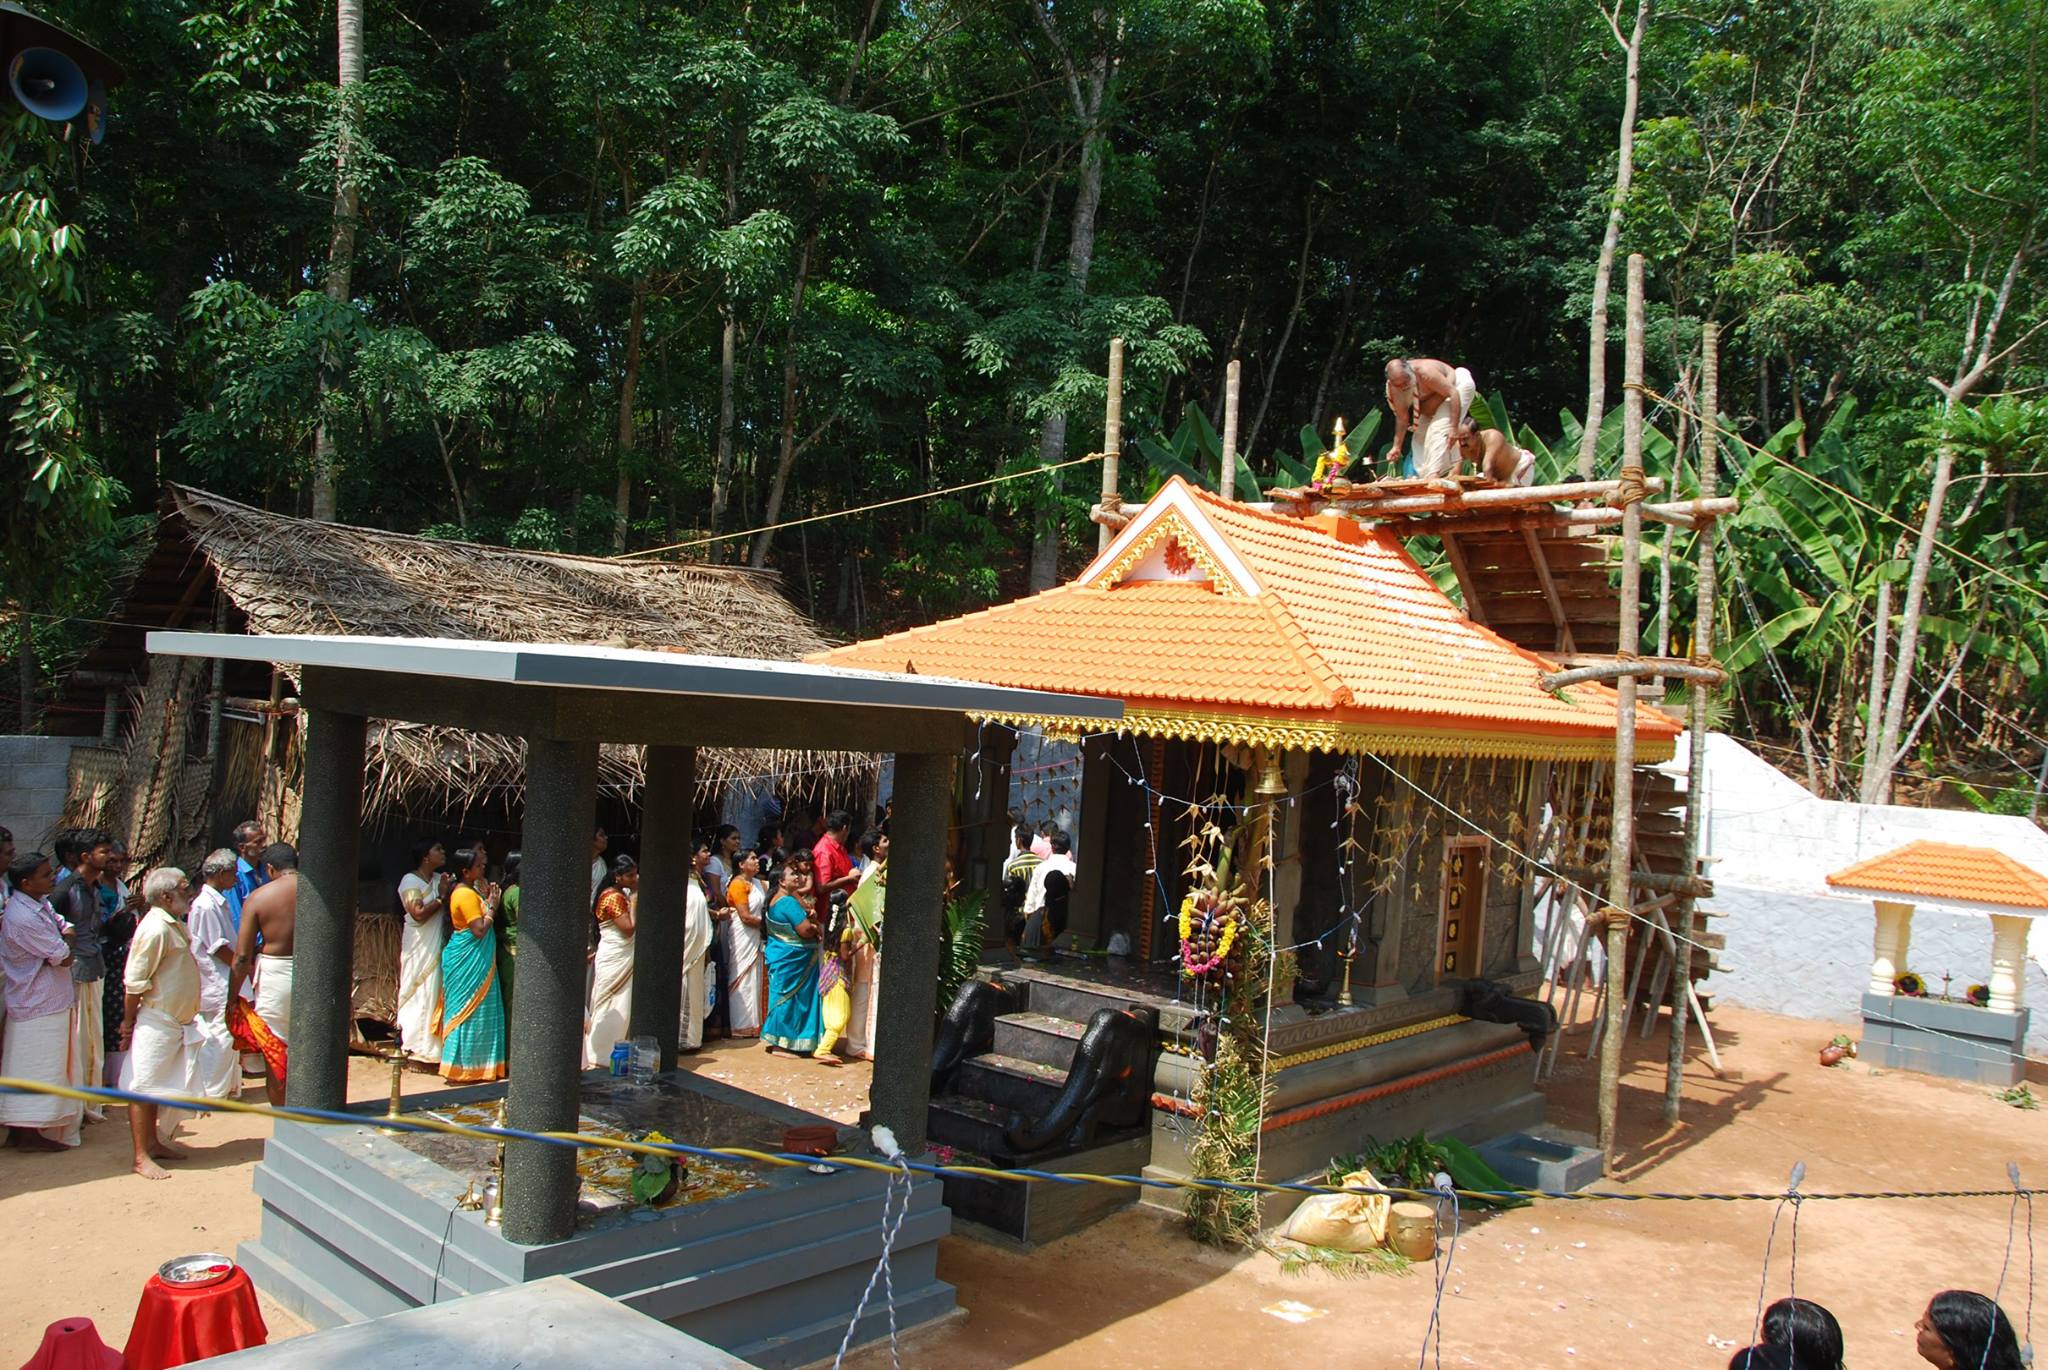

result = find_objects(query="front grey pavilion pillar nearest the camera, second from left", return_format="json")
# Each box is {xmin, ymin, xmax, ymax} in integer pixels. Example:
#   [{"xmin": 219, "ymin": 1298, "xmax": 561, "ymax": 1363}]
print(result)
[{"xmin": 504, "ymin": 737, "xmax": 598, "ymax": 1245}]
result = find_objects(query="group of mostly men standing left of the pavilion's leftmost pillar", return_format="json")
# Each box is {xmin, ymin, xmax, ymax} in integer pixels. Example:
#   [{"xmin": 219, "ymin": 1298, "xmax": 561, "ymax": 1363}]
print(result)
[{"xmin": 0, "ymin": 823, "xmax": 280, "ymax": 1180}]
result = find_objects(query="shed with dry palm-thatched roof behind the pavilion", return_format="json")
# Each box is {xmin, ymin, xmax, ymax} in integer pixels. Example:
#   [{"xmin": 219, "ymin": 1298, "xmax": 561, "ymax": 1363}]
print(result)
[{"xmin": 51, "ymin": 485, "xmax": 872, "ymax": 860}]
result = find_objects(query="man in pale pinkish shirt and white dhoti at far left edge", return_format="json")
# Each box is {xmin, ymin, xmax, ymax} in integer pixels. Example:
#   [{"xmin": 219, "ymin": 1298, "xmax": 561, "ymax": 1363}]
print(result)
[{"xmin": 0, "ymin": 852, "xmax": 84, "ymax": 1151}]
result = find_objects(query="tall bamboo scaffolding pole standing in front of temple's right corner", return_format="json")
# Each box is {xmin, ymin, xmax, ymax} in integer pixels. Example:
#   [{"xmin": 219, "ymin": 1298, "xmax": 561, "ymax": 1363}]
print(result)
[{"xmin": 1599, "ymin": 252, "xmax": 1647, "ymax": 1175}]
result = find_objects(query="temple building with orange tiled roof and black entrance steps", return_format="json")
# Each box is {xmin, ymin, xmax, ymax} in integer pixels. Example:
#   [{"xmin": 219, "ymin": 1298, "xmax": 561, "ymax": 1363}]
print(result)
[{"xmin": 811, "ymin": 479, "xmax": 1681, "ymax": 1237}]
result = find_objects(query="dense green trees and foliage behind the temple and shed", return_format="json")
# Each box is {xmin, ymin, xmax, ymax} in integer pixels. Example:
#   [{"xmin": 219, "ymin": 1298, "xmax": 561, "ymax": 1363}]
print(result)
[{"xmin": 0, "ymin": 0, "xmax": 2048, "ymax": 809}]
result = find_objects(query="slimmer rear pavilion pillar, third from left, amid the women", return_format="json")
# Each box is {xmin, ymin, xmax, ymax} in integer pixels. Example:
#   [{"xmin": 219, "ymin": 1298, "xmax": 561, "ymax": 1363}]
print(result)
[{"xmin": 629, "ymin": 747, "xmax": 696, "ymax": 1071}]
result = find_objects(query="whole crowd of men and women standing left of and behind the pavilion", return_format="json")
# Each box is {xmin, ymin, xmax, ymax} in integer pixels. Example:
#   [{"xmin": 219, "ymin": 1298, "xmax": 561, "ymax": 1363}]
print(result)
[{"xmin": 0, "ymin": 790, "xmax": 889, "ymax": 1180}]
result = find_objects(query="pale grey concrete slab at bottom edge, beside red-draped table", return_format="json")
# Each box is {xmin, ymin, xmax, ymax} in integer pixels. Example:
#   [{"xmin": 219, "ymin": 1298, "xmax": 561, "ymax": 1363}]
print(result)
[{"xmin": 205, "ymin": 1276, "xmax": 748, "ymax": 1370}]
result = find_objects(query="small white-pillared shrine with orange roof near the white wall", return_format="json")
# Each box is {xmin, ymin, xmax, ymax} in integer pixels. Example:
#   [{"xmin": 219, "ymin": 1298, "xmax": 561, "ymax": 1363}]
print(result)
[{"xmin": 1827, "ymin": 842, "xmax": 2048, "ymax": 1085}]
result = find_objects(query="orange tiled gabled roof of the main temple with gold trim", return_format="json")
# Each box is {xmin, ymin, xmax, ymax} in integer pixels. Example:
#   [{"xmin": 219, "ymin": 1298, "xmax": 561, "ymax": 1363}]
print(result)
[{"xmin": 811, "ymin": 479, "xmax": 1679, "ymax": 758}]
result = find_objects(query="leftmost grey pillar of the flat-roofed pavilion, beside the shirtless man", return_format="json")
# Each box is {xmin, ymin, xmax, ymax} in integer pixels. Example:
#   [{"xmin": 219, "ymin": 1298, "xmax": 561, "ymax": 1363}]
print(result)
[{"xmin": 285, "ymin": 709, "xmax": 365, "ymax": 1108}]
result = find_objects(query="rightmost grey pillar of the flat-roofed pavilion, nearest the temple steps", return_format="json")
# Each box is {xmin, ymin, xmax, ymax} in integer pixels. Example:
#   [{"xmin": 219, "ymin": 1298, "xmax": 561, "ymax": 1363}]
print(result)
[{"xmin": 868, "ymin": 754, "xmax": 954, "ymax": 1155}]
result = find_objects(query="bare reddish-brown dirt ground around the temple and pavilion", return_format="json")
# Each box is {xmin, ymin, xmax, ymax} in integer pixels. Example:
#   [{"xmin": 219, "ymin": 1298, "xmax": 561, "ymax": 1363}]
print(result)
[{"xmin": 0, "ymin": 1008, "xmax": 2048, "ymax": 1370}]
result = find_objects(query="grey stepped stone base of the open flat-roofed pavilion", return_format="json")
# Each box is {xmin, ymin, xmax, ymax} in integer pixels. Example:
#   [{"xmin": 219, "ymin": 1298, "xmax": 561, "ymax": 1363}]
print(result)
[{"xmin": 238, "ymin": 1075, "xmax": 954, "ymax": 1368}]
